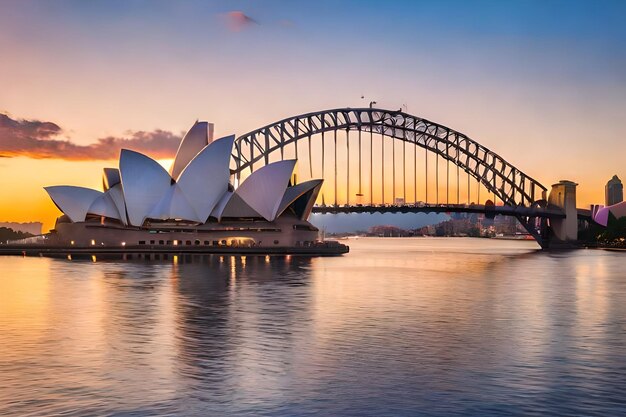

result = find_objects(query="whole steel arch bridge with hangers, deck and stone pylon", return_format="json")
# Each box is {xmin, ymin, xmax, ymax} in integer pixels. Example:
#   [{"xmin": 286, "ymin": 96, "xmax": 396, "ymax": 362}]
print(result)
[{"xmin": 231, "ymin": 107, "xmax": 587, "ymax": 248}]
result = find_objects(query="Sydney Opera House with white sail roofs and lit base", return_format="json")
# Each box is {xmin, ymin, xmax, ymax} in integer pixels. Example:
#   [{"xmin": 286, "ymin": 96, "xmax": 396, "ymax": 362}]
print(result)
[{"xmin": 46, "ymin": 118, "xmax": 347, "ymax": 252}]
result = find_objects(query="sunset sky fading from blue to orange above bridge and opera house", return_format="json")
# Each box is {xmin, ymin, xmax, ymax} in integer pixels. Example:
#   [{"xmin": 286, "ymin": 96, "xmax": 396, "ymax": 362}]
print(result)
[{"xmin": 0, "ymin": 0, "xmax": 626, "ymax": 227}]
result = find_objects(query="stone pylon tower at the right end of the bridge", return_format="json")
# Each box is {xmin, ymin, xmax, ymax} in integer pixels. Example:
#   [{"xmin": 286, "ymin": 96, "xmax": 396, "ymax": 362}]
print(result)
[{"xmin": 547, "ymin": 180, "xmax": 578, "ymax": 248}]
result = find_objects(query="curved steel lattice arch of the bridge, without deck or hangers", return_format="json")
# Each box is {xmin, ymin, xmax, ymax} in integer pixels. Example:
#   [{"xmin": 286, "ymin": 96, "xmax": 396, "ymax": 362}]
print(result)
[{"xmin": 232, "ymin": 108, "xmax": 547, "ymax": 207}]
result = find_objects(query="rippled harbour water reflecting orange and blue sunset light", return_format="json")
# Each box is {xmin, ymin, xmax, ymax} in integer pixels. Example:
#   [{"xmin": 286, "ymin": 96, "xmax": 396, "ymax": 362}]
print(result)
[{"xmin": 0, "ymin": 238, "xmax": 626, "ymax": 416}]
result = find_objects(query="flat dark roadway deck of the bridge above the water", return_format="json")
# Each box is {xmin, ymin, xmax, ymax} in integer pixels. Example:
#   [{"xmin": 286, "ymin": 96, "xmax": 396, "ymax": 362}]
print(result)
[{"xmin": 313, "ymin": 203, "xmax": 565, "ymax": 219}]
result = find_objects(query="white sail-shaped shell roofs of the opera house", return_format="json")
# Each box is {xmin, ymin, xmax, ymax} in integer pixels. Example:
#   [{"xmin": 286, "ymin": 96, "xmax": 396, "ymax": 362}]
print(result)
[{"xmin": 45, "ymin": 122, "xmax": 322, "ymax": 229}]
